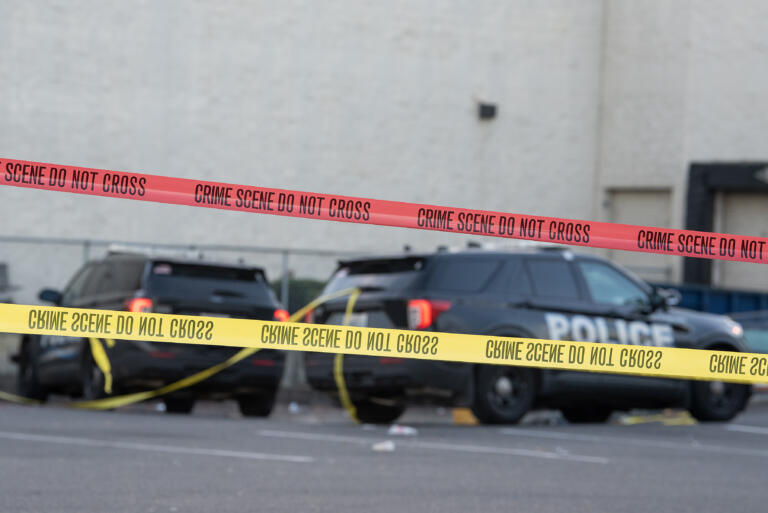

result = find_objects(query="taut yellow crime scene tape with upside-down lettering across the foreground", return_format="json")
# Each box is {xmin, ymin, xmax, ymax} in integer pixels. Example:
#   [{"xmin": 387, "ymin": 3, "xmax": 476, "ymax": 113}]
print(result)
[{"xmin": 0, "ymin": 293, "xmax": 768, "ymax": 384}]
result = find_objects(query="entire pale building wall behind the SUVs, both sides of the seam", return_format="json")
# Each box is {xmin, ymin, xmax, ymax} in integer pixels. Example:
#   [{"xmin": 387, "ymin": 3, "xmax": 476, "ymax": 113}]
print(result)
[{"xmin": 0, "ymin": 0, "xmax": 768, "ymax": 301}]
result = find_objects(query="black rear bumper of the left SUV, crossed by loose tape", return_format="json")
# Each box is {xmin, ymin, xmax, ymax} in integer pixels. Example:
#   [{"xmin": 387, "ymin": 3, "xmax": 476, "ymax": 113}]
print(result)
[{"xmin": 107, "ymin": 340, "xmax": 285, "ymax": 395}]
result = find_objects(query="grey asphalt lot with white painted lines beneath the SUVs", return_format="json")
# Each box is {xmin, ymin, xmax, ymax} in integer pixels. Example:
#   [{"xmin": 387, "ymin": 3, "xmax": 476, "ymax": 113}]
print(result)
[{"xmin": 0, "ymin": 396, "xmax": 768, "ymax": 513}]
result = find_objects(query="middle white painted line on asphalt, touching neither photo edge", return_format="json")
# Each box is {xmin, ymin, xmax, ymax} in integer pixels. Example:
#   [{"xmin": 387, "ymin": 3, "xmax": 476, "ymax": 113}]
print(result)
[{"xmin": 258, "ymin": 429, "xmax": 610, "ymax": 464}]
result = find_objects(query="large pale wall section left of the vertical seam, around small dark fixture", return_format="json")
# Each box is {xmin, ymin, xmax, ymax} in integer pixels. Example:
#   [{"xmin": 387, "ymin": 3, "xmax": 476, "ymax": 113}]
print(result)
[{"xmin": 0, "ymin": 0, "xmax": 602, "ymax": 300}]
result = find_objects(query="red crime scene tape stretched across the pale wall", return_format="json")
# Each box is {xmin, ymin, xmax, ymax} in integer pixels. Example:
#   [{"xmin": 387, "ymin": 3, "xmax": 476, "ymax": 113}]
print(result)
[{"xmin": 0, "ymin": 159, "xmax": 768, "ymax": 264}]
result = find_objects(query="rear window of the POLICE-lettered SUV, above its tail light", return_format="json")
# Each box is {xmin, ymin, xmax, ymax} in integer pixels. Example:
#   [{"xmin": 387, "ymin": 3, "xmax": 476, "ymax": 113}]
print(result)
[{"xmin": 323, "ymin": 257, "xmax": 426, "ymax": 294}]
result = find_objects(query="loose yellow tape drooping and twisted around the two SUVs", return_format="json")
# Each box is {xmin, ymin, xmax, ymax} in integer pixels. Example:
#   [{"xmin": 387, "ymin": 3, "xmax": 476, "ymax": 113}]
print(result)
[{"xmin": 0, "ymin": 289, "xmax": 360, "ymax": 408}]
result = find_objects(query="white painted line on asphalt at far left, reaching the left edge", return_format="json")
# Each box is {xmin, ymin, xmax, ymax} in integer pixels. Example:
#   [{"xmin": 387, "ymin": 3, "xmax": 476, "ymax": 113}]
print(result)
[{"xmin": 0, "ymin": 431, "xmax": 315, "ymax": 463}]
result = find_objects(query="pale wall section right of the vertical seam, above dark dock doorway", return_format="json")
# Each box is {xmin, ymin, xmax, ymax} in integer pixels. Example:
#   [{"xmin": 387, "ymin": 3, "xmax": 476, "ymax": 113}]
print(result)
[{"xmin": 595, "ymin": 0, "xmax": 768, "ymax": 286}]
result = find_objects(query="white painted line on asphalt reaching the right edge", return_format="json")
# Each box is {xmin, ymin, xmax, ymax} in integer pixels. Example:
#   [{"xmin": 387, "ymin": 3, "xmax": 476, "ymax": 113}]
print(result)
[{"xmin": 499, "ymin": 428, "xmax": 768, "ymax": 457}]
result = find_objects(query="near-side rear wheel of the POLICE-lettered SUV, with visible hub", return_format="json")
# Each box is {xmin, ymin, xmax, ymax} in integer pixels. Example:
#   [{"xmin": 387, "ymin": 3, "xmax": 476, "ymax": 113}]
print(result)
[{"xmin": 472, "ymin": 365, "xmax": 536, "ymax": 424}]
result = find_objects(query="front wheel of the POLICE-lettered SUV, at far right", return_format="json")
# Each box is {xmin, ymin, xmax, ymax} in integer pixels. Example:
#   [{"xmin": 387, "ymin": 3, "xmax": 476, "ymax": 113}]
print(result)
[{"xmin": 690, "ymin": 381, "xmax": 749, "ymax": 422}]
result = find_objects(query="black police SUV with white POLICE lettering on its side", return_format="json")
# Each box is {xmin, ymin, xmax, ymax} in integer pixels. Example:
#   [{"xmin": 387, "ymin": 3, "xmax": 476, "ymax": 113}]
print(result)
[{"xmin": 305, "ymin": 249, "xmax": 751, "ymax": 423}]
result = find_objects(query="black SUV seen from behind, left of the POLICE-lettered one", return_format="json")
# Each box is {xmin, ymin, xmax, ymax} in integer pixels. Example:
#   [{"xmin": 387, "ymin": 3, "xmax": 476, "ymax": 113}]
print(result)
[{"xmin": 16, "ymin": 253, "xmax": 288, "ymax": 416}]
